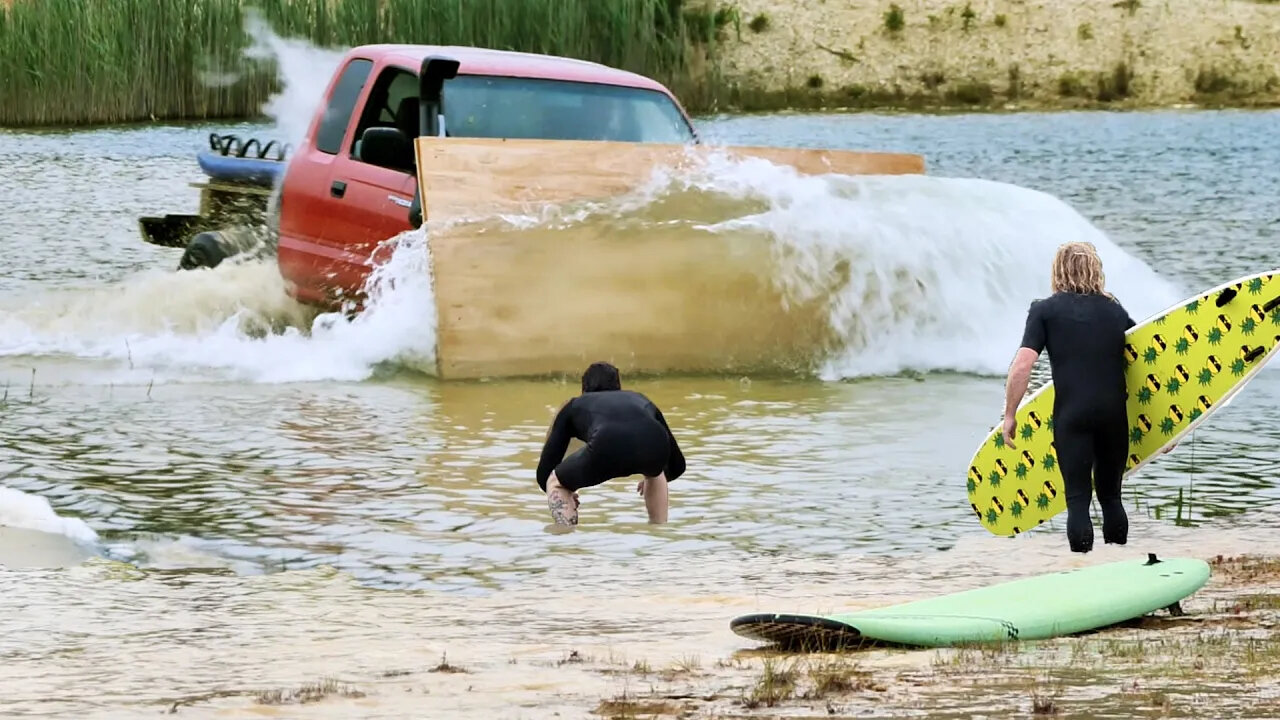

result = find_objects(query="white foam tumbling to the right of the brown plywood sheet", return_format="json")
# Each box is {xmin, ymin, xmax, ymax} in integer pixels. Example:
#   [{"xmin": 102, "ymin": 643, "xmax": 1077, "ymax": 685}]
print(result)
[{"xmin": 752, "ymin": 151, "xmax": 1183, "ymax": 378}]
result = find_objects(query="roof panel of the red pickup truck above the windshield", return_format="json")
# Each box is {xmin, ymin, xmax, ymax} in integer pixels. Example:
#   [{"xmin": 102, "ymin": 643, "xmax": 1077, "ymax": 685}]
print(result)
[{"xmin": 348, "ymin": 44, "xmax": 671, "ymax": 95}]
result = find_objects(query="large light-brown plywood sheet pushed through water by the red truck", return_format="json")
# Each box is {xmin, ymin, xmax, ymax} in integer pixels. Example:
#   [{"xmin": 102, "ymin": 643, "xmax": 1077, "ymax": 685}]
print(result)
[{"xmin": 417, "ymin": 137, "xmax": 923, "ymax": 378}]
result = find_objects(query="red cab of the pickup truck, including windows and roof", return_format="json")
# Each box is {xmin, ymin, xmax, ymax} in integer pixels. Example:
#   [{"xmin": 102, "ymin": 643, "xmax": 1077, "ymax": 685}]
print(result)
[{"xmin": 276, "ymin": 45, "xmax": 698, "ymax": 309}]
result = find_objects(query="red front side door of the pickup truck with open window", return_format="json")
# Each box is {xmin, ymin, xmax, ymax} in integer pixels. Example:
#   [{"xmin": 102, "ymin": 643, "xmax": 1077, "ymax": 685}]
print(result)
[{"xmin": 323, "ymin": 65, "xmax": 419, "ymax": 303}]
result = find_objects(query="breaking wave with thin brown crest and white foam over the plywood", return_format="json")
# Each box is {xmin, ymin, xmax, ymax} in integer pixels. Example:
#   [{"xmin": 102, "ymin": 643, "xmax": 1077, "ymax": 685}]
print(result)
[{"xmin": 465, "ymin": 148, "xmax": 1187, "ymax": 379}]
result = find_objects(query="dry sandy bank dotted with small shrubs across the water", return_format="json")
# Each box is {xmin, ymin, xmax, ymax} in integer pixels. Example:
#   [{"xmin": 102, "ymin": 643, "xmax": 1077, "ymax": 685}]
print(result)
[{"xmin": 716, "ymin": 0, "xmax": 1280, "ymax": 109}]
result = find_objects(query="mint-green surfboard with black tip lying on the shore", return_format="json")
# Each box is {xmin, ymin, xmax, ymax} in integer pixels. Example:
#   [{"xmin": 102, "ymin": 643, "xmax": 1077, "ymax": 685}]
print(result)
[{"xmin": 730, "ymin": 555, "xmax": 1210, "ymax": 650}]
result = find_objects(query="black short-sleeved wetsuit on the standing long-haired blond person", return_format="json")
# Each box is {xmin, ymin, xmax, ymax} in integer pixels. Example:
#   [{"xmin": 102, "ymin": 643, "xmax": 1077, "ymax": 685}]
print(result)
[{"xmin": 1023, "ymin": 292, "xmax": 1134, "ymax": 552}]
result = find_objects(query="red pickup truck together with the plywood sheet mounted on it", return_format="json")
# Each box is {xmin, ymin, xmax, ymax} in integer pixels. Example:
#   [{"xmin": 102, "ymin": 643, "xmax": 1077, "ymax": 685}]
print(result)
[{"xmin": 140, "ymin": 45, "xmax": 924, "ymax": 379}]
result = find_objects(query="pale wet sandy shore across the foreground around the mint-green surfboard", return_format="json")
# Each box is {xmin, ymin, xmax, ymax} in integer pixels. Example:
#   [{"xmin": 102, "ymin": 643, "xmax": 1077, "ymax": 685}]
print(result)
[{"xmin": 0, "ymin": 521, "xmax": 1280, "ymax": 719}]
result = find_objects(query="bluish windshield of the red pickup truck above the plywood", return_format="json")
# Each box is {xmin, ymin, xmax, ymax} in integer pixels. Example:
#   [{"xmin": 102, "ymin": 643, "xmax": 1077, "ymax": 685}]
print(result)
[{"xmin": 444, "ymin": 76, "xmax": 694, "ymax": 143}]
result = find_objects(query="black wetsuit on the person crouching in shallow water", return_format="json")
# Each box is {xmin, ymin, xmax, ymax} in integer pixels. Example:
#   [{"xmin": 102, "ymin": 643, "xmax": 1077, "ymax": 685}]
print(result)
[{"xmin": 538, "ymin": 389, "xmax": 685, "ymax": 492}]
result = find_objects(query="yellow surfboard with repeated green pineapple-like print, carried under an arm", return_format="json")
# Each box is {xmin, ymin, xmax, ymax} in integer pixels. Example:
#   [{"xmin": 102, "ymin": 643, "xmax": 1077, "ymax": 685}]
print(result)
[{"xmin": 966, "ymin": 269, "xmax": 1280, "ymax": 536}]
